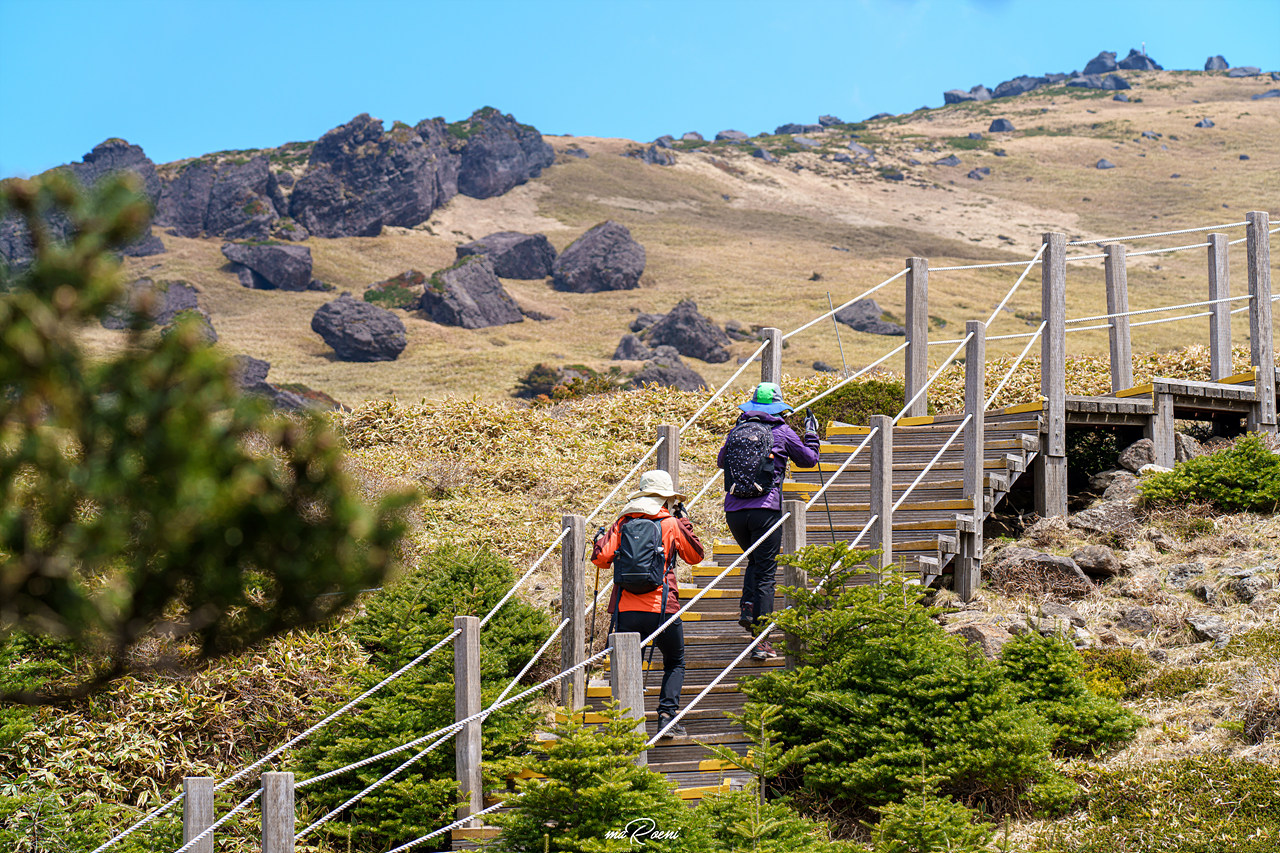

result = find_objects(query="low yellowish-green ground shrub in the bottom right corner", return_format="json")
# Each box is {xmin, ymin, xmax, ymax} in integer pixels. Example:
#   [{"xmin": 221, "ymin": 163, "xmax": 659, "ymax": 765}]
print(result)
[{"xmin": 1056, "ymin": 756, "xmax": 1280, "ymax": 853}]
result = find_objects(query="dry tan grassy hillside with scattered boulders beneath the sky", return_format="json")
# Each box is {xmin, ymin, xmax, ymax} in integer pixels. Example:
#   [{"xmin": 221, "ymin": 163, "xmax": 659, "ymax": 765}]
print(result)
[{"xmin": 107, "ymin": 72, "xmax": 1280, "ymax": 405}]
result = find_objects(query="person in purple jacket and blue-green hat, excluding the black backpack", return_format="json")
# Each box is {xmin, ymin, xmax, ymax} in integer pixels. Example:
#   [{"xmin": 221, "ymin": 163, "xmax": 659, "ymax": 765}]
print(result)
[{"xmin": 716, "ymin": 382, "xmax": 819, "ymax": 661}]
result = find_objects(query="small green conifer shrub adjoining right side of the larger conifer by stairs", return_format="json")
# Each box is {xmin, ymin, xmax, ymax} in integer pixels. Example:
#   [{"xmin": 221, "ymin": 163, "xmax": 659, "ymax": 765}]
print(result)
[{"xmin": 1000, "ymin": 633, "xmax": 1143, "ymax": 754}]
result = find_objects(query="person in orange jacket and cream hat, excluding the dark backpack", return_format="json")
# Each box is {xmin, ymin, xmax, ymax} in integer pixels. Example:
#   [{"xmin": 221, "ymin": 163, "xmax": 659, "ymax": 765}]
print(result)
[{"xmin": 591, "ymin": 470, "xmax": 705, "ymax": 738}]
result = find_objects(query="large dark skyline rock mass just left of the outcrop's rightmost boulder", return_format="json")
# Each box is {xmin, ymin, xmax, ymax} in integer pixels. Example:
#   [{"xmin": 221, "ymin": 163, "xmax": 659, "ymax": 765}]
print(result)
[{"xmin": 289, "ymin": 113, "xmax": 458, "ymax": 237}]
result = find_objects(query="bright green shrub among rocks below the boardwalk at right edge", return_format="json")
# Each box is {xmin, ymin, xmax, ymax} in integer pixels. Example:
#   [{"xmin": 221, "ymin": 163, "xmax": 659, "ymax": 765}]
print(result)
[{"xmin": 1138, "ymin": 435, "xmax": 1280, "ymax": 512}]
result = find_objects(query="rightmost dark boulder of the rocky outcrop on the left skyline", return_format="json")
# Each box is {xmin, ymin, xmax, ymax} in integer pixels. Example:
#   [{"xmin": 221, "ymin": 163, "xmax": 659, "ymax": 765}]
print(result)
[{"xmin": 449, "ymin": 106, "xmax": 556, "ymax": 199}]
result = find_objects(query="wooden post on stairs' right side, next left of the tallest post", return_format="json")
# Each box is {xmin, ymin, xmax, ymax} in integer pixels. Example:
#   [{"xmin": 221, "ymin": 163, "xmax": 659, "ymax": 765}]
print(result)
[{"xmin": 955, "ymin": 320, "xmax": 987, "ymax": 601}]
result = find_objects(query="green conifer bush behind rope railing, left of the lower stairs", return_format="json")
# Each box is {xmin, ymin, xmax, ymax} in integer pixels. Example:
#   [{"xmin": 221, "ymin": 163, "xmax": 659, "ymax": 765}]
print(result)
[{"xmin": 296, "ymin": 546, "xmax": 550, "ymax": 849}]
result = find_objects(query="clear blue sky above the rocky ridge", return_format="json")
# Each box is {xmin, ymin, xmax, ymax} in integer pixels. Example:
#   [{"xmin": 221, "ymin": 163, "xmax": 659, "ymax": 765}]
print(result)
[{"xmin": 0, "ymin": 0, "xmax": 1280, "ymax": 175}]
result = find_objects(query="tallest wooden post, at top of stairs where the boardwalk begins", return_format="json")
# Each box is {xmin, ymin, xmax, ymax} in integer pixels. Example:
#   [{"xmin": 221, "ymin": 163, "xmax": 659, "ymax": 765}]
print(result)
[{"xmin": 1036, "ymin": 232, "xmax": 1066, "ymax": 517}]
